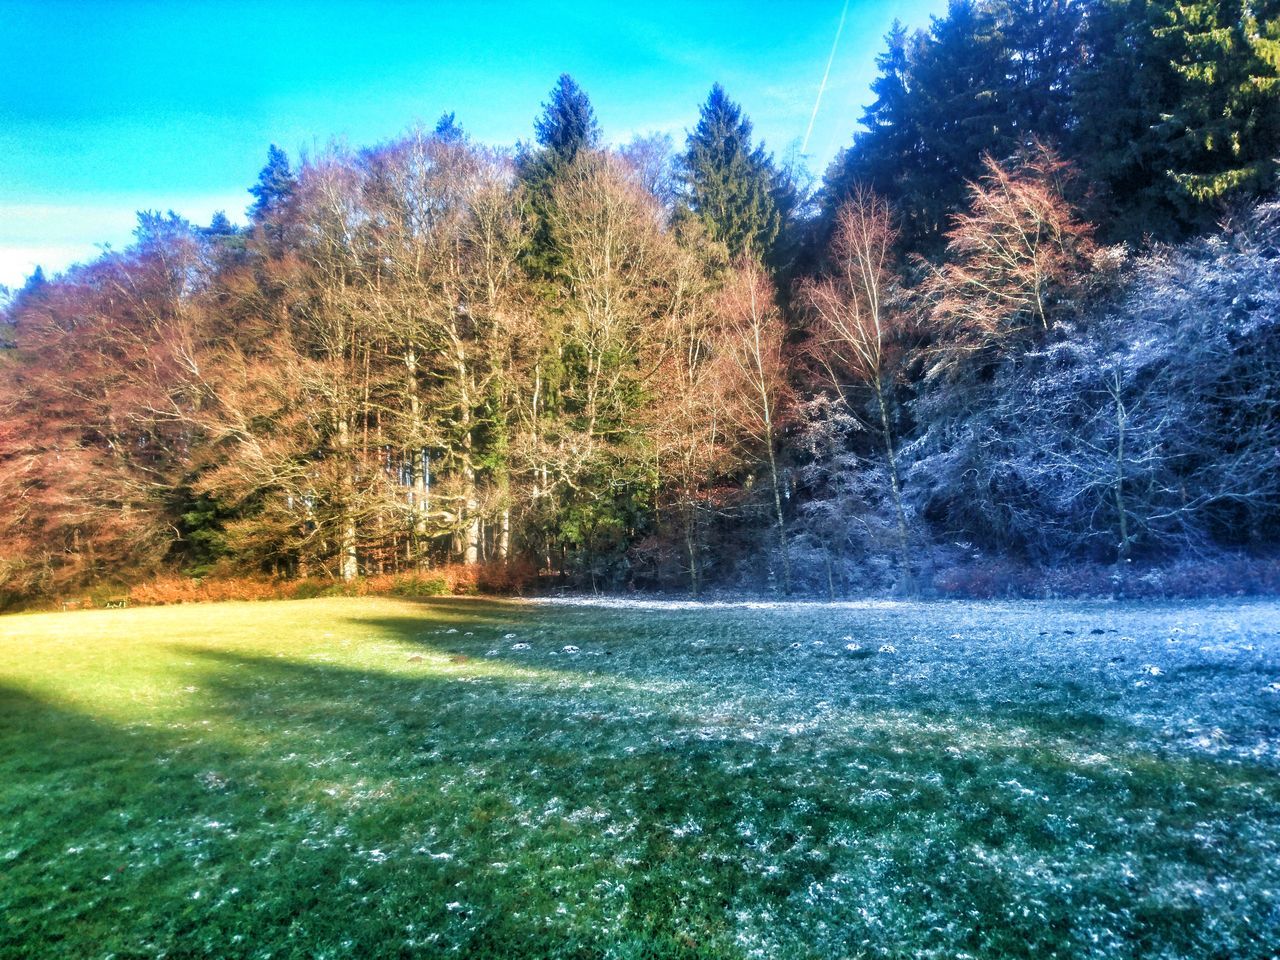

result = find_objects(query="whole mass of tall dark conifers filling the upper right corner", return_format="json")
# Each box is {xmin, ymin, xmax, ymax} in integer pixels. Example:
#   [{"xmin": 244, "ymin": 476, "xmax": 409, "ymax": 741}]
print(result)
[{"xmin": 824, "ymin": 0, "xmax": 1280, "ymax": 256}]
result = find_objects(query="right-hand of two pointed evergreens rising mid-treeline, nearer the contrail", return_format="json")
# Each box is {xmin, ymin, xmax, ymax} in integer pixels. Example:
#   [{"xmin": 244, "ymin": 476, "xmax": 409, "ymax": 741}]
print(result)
[{"xmin": 681, "ymin": 83, "xmax": 785, "ymax": 262}]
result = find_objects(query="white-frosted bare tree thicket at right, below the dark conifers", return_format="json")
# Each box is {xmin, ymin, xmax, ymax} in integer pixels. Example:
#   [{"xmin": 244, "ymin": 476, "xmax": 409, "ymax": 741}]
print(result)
[{"xmin": 908, "ymin": 205, "xmax": 1280, "ymax": 566}]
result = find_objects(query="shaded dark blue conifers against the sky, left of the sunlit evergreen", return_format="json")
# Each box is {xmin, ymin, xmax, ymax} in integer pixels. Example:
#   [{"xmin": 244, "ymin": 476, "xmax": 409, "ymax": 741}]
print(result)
[{"xmin": 823, "ymin": 0, "xmax": 1082, "ymax": 252}]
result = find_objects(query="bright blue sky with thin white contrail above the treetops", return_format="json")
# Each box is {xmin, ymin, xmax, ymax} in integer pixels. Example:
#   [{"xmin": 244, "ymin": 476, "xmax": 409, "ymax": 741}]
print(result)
[{"xmin": 0, "ymin": 0, "xmax": 945, "ymax": 285}]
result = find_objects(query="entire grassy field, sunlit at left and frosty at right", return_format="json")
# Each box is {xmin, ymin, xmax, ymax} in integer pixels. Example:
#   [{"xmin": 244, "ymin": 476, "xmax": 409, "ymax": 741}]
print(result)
[{"xmin": 0, "ymin": 599, "xmax": 1280, "ymax": 959}]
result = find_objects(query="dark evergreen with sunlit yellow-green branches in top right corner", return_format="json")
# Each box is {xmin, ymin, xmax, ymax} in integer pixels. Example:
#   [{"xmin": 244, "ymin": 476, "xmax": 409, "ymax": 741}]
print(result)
[{"xmin": 1073, "ymin": 0, "xmax": 1280, "ymax": 239}]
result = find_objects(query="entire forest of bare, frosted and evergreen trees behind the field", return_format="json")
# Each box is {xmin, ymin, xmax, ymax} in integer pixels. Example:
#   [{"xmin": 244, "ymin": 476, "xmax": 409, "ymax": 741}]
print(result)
[{"xmin": 0, "ymin": 0, "xmax": 1280, "ymax": 605}]
